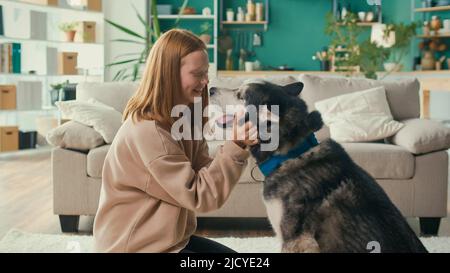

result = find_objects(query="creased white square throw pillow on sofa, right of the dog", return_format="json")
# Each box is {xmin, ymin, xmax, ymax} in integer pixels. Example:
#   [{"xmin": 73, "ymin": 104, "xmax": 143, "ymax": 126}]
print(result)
[{"xmin": 315, "ymin": 86, "xmax": 403, "ymax": 142}]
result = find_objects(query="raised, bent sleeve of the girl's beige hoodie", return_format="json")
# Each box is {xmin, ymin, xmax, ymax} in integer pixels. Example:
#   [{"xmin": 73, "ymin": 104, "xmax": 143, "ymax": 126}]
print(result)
[{"xmin": 147, "ymin": 135, "xmax": 249, "ymax": 212}]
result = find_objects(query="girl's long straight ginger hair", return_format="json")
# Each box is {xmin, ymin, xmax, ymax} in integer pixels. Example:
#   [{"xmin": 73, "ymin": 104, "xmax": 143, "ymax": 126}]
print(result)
[{"xmin": 123, "ymin": 29, "xmax": 208, "ymax": 126}]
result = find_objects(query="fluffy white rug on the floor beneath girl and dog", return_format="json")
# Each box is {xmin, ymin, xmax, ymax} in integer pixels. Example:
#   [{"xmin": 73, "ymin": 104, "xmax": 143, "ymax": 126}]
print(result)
[{"xmin": 0, "ymin": 229, "xmax": 450, "ymax": 253}]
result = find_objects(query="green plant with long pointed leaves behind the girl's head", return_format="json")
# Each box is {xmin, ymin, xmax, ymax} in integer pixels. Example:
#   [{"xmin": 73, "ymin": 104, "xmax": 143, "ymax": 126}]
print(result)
[{"xmin": 105, "ymin": 0, "xmax": 189, "ymax": 81}]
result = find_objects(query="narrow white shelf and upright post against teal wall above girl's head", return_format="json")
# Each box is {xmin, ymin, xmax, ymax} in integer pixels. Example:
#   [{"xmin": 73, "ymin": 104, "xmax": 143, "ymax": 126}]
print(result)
[{"xmin": 152, "ymin": 0, "xmax": 219, "ymax": 77}]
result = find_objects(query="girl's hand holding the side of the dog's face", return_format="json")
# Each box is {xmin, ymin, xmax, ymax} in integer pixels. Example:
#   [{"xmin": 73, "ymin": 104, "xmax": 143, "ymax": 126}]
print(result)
[{"xmin": 232, "ymin": 110, "xmax": 259, "ymax": 148}]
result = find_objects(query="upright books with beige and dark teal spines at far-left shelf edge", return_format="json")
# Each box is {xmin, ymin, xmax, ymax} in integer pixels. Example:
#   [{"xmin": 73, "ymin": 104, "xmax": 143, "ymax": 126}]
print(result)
[{"xmin": 0, "ymin": 43, "xmax": 22, "ymax": 74}]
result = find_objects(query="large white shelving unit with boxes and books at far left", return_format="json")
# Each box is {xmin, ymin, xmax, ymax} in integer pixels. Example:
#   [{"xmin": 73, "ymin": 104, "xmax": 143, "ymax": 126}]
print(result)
[{"xmin": 0, "ymin": 0, "xmax": 105, "ymax": 134}]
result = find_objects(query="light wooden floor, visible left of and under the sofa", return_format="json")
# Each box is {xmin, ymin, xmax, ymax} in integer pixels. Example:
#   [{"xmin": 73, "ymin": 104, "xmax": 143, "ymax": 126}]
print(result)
[{"xmin": 0, "ymin": 149, "xmax": 450, "ymax": 238}]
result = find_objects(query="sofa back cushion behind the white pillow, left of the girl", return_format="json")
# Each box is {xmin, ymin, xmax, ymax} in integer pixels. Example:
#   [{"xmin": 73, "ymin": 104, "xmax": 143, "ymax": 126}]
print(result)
[{"xmin": 77, "ymin": 82, "xmax": 138, "ymax": 113}]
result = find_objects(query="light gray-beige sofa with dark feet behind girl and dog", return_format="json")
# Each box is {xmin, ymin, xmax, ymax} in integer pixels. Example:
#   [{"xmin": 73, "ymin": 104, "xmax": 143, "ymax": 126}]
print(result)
[{"xmin": 52, "ymin": 74, "xmax": 450, "ymax": 234}]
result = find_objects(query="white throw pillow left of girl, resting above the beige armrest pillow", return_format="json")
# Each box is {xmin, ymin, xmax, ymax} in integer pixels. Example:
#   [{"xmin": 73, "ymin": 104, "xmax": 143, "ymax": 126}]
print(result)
[{"xmin": 56, "ymin": 99, "xmax": 122, "ymax": 144}]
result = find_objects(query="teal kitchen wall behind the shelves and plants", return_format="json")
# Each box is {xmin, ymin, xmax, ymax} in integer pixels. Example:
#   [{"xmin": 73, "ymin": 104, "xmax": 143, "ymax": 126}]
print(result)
[{"xmin": 158, "ymin": 0, "xmax": 450, "ymax": 70}]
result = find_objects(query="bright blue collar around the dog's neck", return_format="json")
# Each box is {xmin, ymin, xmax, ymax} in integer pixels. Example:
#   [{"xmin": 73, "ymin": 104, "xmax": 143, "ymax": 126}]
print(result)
[{"xmin": 258, "ymin": 134, "xmax": 319, "ymax": 177}]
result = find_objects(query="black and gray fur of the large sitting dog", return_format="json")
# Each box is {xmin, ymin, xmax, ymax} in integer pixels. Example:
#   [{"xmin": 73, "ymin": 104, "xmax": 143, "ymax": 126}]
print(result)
[{"xmin": 211, "ymin": 82, "xmax": 427, "ymax": 253}]
